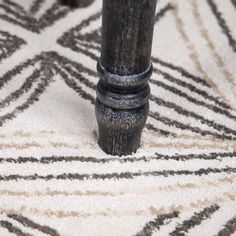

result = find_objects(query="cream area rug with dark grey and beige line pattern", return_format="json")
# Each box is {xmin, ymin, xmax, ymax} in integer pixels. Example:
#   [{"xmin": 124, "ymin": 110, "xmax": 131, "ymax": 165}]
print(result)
[{"xmin": 0, "ymin": 0, "xmax": 236, "ymax": 236}]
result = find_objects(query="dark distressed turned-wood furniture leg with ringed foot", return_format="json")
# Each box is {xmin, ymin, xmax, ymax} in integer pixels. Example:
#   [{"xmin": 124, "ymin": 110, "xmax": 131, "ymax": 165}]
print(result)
[{"xmin": 96, "ymin": 0, "xmax": 156, "ymax": 156}]
